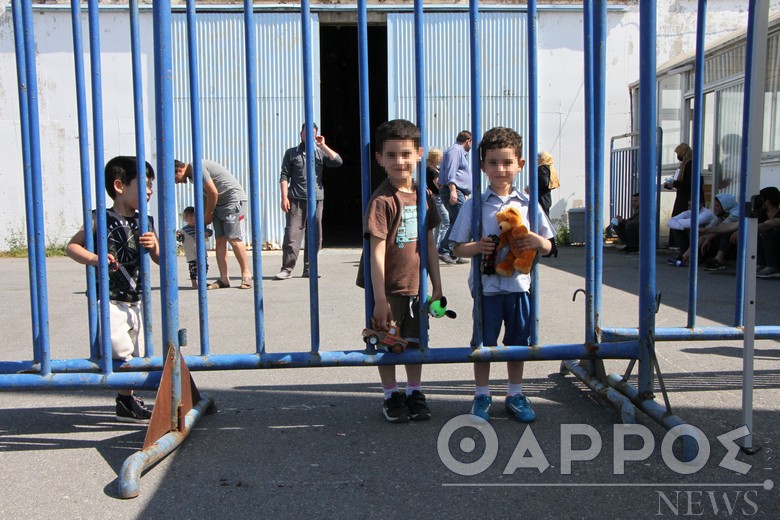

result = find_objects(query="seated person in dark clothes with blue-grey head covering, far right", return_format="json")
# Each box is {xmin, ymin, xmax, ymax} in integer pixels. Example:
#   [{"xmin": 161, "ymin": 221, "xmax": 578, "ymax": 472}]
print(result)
[{"xmin": 699, "ymin": 193, "xmax": 739, "ymax": 271}]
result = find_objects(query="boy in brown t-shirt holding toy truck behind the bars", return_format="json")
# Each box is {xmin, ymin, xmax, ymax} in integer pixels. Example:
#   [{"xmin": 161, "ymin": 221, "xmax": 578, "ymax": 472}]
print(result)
[{"xmin": 363, "ymin": 119, "xmax": 442, "ymax": 422}]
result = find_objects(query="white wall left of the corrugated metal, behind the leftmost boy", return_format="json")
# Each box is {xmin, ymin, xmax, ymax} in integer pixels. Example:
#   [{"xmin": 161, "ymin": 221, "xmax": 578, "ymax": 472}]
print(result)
[{"xmin": 0, "ymin": 10, "xmax": 156, "ymax": 250}]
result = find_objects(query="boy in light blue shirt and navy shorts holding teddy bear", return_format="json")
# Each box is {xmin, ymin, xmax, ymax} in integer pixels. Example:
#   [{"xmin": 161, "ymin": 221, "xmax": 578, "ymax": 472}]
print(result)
[{"xmin": 450, "ymin": 127, "xmax": 555, "ymax": 422}]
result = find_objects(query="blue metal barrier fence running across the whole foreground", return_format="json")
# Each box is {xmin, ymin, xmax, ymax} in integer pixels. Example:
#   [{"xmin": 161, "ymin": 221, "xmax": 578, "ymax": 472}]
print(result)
[{"xmin": 0, "ymin": 0, "xmax": 780, "ymax": 496}]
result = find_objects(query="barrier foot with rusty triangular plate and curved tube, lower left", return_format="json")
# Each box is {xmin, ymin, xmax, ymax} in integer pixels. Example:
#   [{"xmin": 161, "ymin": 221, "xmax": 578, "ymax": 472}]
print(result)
[{"xmin": 117, "ymin": 348, "xmax": 216, "ymax": 498}]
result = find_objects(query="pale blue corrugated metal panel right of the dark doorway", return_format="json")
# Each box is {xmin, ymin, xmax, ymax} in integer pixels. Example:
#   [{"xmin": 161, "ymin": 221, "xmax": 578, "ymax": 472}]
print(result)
[{"xmin": 387, "ymin": 12, "xmax": 528, "ymax": 186}]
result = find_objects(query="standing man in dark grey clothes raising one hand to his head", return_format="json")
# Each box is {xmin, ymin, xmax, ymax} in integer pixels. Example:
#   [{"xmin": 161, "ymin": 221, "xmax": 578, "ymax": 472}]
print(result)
[{"xmin": 275, "ymin": 124, "xmax": 344, "ymax": 280}]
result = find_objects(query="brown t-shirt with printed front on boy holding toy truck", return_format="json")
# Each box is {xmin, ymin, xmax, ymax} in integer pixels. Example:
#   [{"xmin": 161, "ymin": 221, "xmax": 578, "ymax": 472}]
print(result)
[{"xmin": 358, "ymin": 180, "xmax": 441, "ymax": 296}]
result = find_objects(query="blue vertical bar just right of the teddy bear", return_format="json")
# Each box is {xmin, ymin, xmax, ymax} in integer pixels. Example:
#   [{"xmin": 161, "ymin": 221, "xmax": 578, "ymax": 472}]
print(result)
[{"xmin": 526, "ymin": 0, "xmax": 541, "ymax": 345}]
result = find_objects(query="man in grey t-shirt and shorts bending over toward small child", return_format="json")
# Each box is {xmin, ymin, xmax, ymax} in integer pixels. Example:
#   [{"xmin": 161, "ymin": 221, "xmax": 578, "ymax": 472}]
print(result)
[{"xmin": 174, "ymin": 160, "xmax": 252, "ymax": 289}]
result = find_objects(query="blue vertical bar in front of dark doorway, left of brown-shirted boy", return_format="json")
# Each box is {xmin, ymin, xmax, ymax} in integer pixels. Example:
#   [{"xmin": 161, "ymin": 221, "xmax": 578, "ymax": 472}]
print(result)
[{"xmin": 357, "ymin": 0, "xmax": 374, "ymax": 327}]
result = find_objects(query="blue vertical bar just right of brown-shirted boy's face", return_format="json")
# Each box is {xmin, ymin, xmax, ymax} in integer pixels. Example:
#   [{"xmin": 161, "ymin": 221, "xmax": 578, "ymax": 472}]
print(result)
[{"xmin": 414, "ymin": 0, "xmax": 435, "ymax": 348}]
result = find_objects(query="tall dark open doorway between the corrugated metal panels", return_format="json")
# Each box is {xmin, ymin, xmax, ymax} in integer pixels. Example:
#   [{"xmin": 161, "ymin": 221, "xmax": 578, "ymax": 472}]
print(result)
[{"xmin": 320, "ymin": 25, "xmax": 387, "ymax": 247}]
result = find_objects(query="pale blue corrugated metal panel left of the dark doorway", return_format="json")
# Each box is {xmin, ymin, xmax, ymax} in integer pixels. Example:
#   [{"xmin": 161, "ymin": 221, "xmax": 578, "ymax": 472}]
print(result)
[{"xmin": 172, "ymin": 13, "xmax": 320, "ymax": 245}]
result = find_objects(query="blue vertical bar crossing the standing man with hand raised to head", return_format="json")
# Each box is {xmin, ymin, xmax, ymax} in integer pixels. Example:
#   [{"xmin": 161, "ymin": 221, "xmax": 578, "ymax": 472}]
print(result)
[{"xmin": 301, "ymin": 0, "xmax": 322, "ymax": 354}]
